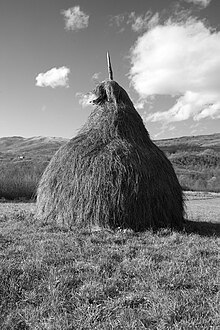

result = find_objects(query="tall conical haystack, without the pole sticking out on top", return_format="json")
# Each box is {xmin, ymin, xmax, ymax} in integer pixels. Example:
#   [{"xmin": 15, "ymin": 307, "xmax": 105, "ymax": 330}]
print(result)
[{"xmin": 37, "ymin": 80, "xmax": 184, "ymax": 231}]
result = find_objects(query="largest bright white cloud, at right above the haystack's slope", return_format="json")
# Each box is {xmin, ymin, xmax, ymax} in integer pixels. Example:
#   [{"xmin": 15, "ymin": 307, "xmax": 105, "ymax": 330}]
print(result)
[{"xmin": 130, "ymin": 19, "xmax": 220, "ymax": 122}]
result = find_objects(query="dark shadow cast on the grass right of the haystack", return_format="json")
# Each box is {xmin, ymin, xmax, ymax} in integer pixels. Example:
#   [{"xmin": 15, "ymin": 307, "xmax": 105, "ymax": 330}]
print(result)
[{"xmin": 185, "ymin": 220, "xmax": 220, "ymax": 237}]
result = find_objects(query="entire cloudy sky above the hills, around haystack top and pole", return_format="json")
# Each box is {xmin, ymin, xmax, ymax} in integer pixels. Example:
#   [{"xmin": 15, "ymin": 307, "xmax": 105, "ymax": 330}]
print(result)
[{"xmin": 0, "ymin": 0, "xmax": 220, "ymax": 139}]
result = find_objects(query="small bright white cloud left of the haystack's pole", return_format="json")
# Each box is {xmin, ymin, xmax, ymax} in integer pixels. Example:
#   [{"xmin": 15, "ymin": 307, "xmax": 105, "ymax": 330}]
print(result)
[{"xmin": 36, "ymin": 66, "xmax": 70, "ymax": 88}]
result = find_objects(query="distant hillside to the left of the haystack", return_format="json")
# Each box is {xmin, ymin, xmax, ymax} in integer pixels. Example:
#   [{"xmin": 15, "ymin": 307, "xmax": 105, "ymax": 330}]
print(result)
[{"xmin": 0, "ymin": 136, "xmax": 67, "ymax": 199}]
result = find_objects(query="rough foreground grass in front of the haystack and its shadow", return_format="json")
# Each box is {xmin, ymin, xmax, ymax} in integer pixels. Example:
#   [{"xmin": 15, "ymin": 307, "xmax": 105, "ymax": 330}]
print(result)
[{"xmin": 0, "ymin": 208, "xmax": 220, "ymax": 330}]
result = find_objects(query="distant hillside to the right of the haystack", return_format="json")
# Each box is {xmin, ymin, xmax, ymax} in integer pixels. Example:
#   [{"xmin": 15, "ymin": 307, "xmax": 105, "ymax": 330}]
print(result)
[{"xmin": 156, "ymin": 134, "xmax": 220, "ymax": 192}]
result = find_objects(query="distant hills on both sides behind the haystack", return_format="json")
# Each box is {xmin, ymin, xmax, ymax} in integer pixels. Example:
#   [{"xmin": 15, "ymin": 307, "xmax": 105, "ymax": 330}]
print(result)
[{"xmin": 0, "ymin": 133, "xmax": 220, "ymax": 199}]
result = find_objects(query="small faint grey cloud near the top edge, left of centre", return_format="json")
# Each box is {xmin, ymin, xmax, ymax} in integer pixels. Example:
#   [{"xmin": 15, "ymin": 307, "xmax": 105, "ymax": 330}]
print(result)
[{"xmin": 61, "ymin": 6, "xmax": 89, "ymax": 31}]
